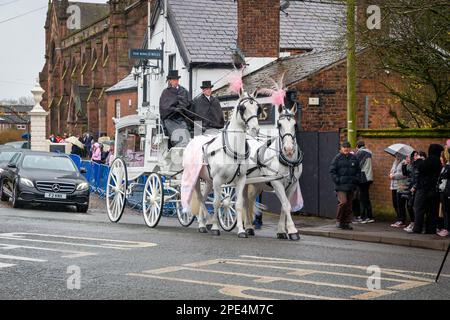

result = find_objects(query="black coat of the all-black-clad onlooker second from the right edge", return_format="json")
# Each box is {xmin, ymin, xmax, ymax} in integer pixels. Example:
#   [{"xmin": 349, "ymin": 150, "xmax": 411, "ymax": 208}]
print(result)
[{"xmin": 414, "ymin": 144, "xmax": 444, "ymax": 192}]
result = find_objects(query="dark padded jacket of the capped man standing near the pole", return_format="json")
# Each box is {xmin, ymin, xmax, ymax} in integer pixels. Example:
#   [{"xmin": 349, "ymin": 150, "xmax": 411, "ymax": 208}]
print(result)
[{"xmin": 330, "ymin": 153, "xmax": 361, "ymax": 192}]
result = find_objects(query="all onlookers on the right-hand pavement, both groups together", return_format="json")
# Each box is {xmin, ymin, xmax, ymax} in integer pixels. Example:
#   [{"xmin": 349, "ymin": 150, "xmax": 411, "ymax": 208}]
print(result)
[{"xmin": 330, "ymin": 139, "xmax": 450, "ymax": 237}]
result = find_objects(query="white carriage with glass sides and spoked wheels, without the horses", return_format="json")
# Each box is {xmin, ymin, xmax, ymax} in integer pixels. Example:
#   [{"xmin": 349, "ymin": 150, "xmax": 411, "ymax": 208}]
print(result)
[{"xmin": 106, "ymin": 108, "xmax": 236, "ymax": 231}]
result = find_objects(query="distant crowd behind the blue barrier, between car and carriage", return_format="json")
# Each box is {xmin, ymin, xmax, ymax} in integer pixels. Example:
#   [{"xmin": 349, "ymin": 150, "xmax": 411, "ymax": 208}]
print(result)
[{"xmin": 49, "ymin": 133, "xmax": 114, "ymax": 166}]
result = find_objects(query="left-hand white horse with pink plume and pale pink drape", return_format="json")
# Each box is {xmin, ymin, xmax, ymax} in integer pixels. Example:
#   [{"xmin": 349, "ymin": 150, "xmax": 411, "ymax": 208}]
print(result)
[{"xmin": 181, "ymin": 71, "xmax": 261, "ymax": 238}]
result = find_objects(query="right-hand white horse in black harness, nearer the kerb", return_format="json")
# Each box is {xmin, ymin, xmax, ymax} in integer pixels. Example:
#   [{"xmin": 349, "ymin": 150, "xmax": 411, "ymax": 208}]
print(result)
[{"xmin": 244, "ymin": 103, "xmax": 303, "ymax": 241}]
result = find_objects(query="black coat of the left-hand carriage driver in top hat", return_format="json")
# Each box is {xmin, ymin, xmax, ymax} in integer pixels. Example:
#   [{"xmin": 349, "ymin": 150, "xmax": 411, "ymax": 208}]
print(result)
[{"xmin": 159, "ymin": 86, "xmax": 191, "ymax": 120}]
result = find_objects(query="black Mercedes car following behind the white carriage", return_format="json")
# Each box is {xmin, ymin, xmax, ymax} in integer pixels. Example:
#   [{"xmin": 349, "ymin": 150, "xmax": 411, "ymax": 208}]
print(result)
[{"xmin": 0, "ymin": 151, "xmax": 89, "ymax": 213}]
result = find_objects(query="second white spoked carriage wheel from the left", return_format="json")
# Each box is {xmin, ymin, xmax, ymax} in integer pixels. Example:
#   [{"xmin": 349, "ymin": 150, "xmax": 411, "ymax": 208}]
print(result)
[{"xmin": 142, "ymin": 173, "xmax": 164, "ymax": 228}]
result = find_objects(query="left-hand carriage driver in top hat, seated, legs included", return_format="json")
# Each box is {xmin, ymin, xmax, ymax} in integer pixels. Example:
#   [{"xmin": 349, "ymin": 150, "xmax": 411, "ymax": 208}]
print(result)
[{"xmin": 159, "ymin": 70, "xmax": 190, "ymax": 147}]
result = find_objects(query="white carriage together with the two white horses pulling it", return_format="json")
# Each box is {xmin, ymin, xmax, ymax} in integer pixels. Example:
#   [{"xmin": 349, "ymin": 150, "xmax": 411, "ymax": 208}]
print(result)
[{"xmin": 106, "ymin": 78, "xmax": 302, "ymax": 240}]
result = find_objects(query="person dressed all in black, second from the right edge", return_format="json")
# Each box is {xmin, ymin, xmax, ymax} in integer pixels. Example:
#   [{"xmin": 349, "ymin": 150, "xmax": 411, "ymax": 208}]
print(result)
[{"xmin": 413, "ymin": 144, "xmax": 444, "ymax": 234}]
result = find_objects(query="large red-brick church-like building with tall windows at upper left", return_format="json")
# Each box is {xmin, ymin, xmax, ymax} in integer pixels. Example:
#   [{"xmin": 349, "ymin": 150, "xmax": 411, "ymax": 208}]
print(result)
[{"xmin": 39, "ymin": 0, "xmax": 147, "ymax": 136}]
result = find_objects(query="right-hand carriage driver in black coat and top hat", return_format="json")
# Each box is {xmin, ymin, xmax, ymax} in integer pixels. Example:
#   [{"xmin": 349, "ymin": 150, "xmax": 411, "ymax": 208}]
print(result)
[{"xmin": 192, "ymin": 81, "xmax": 225, "ymax": 132}]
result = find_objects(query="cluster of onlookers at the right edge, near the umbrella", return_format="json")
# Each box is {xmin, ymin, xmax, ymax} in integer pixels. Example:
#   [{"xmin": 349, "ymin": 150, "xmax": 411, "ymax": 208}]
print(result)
[{"xmin": 389, "ymin": 140, "xmax": 450, "ymax": 237}]
